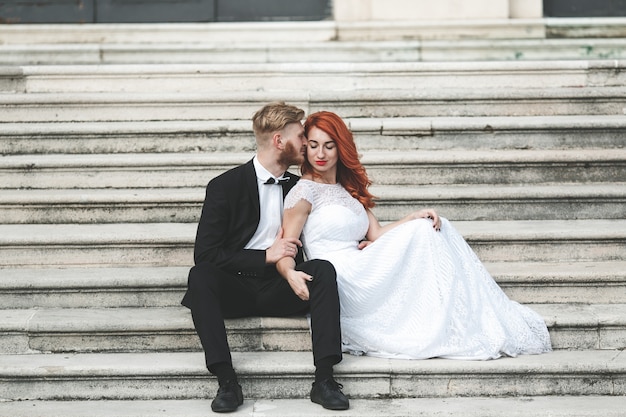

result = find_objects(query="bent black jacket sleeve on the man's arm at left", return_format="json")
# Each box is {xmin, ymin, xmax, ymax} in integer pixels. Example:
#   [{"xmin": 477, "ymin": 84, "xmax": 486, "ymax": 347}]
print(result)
[{"xmin": 194, "ymin": 174, "xmax": 265, "ymax": 276}]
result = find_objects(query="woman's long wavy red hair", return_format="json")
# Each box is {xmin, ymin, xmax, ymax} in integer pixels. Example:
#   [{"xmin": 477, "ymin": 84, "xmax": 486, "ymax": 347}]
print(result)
[{"xmin": 301, "ymin": 111, "xmax": 375, "ymax": 208}]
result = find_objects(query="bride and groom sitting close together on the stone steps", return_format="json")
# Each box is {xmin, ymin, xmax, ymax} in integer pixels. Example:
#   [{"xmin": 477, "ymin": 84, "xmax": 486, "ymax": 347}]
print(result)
[{"xmin": 183, "ymin": 103, "xmax": 551, "ymax": 412}]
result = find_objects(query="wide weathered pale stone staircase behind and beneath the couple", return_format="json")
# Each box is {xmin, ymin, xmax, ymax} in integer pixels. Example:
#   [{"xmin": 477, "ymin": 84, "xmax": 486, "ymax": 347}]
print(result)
[{"xmin": 0, "ymin": 19, "xmax": 626, "ymax": 417}]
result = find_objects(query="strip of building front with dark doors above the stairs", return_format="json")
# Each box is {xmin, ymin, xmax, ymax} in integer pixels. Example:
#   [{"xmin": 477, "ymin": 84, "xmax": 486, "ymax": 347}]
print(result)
[{"xmin": 0, "ymin": 0, "xmax": 626, "ymax": 24}]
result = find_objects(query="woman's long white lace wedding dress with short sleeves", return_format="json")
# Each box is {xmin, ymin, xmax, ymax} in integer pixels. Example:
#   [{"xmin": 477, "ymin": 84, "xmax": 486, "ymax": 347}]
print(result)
[{"xmin": 285, "ymin": 180, "xmax": 551, "ymax": 360}]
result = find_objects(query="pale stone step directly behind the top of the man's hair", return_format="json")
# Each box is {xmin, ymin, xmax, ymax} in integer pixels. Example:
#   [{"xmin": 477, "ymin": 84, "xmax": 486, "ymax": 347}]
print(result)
[{"xmin": 0, "ymin": 87, "xmax": 626, "ymax": 123}]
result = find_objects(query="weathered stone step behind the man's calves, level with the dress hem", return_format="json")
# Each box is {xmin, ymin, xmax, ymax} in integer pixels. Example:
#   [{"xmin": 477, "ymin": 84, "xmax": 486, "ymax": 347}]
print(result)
[{"xmin": 0, "ymin": 300, "xmax": 626, "ymax": 354}]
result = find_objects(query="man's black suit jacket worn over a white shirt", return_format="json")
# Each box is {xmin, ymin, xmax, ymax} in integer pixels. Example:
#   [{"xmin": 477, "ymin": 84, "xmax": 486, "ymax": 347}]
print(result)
[{"xmin": 194, "ymin": 160, "xmax": 302, "ymax": 276}]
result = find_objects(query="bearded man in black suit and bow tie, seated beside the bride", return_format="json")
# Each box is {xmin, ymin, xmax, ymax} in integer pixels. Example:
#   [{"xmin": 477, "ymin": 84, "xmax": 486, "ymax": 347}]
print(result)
[{"xmin": 182, "ymin": 103, "xmax": 349, "ymax": 412}]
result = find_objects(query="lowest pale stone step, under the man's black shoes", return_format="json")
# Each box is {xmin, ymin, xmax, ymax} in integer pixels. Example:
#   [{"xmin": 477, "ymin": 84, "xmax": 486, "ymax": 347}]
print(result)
[{"xmin": 0, "ymin": 393, "xmax": 624, "ymax": 417}]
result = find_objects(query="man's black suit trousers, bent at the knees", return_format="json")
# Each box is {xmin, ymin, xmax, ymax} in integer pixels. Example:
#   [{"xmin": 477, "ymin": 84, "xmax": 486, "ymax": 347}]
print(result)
[{"xmin": 182, "ymin": 260, "xmax": 341, "ymax": 368}]
